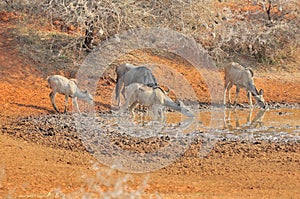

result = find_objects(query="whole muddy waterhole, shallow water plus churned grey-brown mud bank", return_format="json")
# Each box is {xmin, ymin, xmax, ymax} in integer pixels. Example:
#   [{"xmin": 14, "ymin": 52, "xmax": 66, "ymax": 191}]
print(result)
[{"xmin": 2, "ymin": 105, "xmax": 300, "ymax": 173}]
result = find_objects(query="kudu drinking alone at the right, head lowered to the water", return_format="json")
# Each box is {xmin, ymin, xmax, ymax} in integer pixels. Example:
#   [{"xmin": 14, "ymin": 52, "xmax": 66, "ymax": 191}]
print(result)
[{"xmin": 224, "ymin": 62, "xmax": 266, "ymax": 108}]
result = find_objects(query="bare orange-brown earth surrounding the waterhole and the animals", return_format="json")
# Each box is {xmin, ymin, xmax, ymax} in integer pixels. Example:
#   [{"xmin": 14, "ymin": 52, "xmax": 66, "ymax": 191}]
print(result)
[{"xmin": 0, "ymin": 11, "xmax": 300, "ymax": 198}]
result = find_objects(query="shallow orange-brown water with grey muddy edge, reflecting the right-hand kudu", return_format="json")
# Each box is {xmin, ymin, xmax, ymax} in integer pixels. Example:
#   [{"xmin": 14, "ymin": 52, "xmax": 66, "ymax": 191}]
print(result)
[{"xmin": 129, "ymin": 108, "xmax": 300, "ymax": 142}]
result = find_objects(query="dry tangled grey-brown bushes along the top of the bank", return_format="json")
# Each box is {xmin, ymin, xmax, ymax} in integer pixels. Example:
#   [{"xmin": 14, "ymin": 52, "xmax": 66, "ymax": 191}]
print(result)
[{"xmin": 2, "ymin": 0, "xmax": 300, "ymax": 64}]
